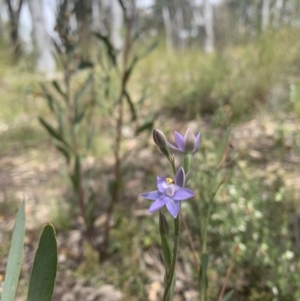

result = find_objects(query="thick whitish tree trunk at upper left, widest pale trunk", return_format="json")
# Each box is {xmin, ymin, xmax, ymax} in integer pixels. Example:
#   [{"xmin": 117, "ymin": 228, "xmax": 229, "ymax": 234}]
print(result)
[{"xmin": 28, "ymin": 0, "xmax": 55, "ymax": 73}]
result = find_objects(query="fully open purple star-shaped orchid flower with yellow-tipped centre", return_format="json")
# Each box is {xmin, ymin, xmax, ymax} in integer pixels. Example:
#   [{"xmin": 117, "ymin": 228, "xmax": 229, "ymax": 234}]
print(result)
[{"xmin": 141, "ymin": 167, "xmax": 195, "ymax": 218}]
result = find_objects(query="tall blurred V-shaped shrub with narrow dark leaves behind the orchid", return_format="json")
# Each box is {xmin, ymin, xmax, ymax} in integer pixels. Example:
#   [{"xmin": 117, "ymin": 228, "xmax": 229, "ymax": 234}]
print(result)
[{"xmin": 39, "ymin": 1, "xmax": 156, "ymax": 261}]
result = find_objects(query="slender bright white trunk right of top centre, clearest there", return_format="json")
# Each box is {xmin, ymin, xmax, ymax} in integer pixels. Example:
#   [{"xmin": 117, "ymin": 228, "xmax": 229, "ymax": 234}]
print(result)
[{"xmin": 203, "ymin": 0, "xmax": 215, "ymax": 53}]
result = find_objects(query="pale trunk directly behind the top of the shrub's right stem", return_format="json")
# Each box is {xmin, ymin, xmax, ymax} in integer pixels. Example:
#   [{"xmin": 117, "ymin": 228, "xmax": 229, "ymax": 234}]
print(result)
[{"xmin": 110, "ymin": 0, "xmax": 124, "ymax": 49}]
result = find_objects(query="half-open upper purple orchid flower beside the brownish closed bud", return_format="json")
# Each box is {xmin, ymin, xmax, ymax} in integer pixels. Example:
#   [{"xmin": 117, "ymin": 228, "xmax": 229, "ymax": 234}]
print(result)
[{"xmin": 167, "ymin": 128, "xmax": 200, "ymax": 154}]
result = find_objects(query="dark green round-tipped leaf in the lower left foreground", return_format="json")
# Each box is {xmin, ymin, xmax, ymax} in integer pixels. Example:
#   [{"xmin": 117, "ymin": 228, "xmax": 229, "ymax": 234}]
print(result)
[{"xmin": 27, "ymin": 224, "xmax": 57, "ymax": 301}]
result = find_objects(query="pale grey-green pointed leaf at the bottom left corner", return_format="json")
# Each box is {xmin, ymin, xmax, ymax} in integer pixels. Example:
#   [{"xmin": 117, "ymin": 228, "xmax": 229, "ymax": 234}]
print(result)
[{"xmin": 1, "ymin": 201, "xmax": 25, "ymax": 301}]
